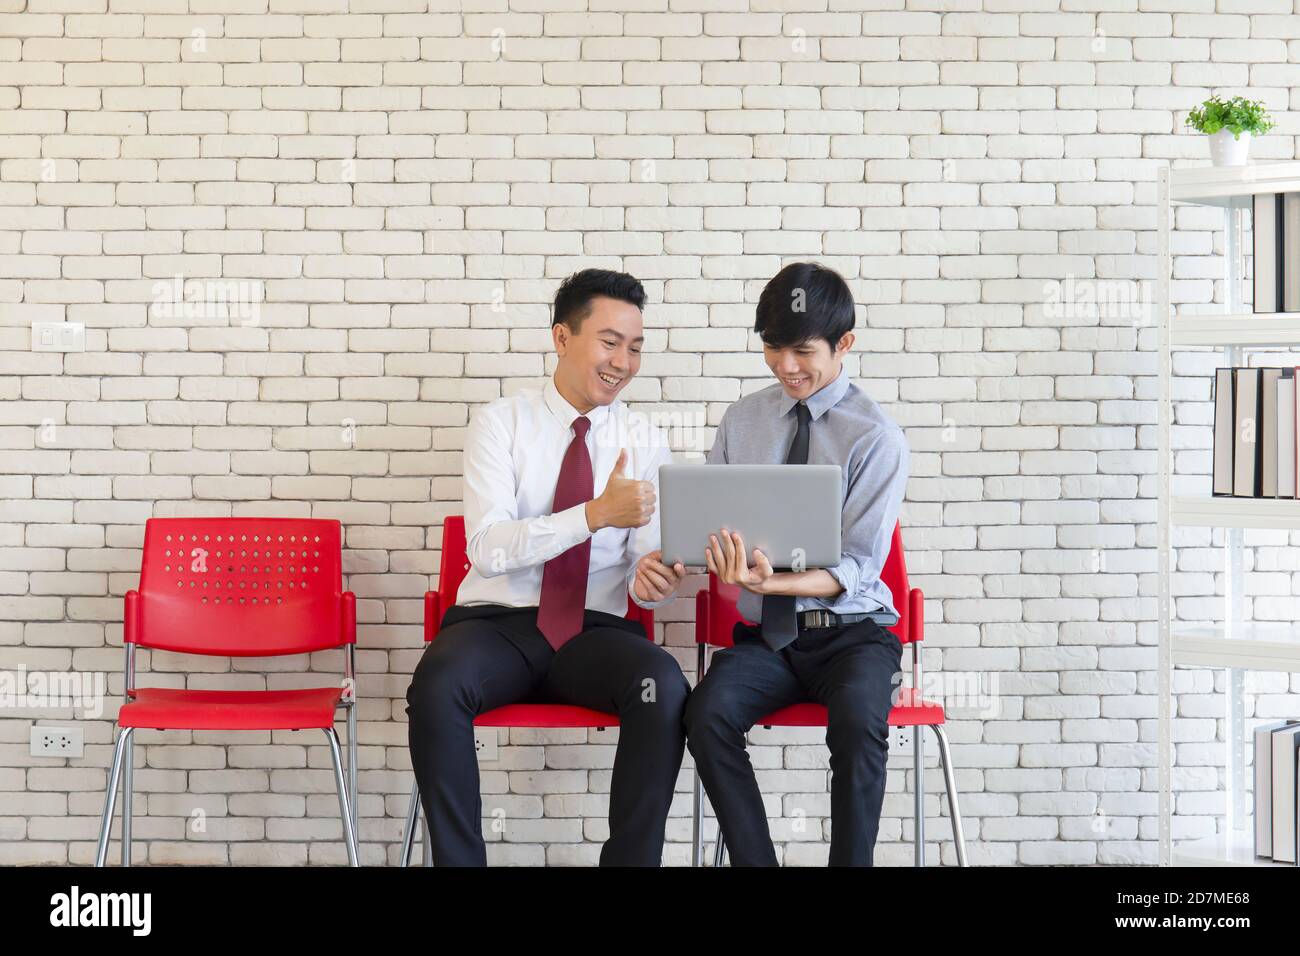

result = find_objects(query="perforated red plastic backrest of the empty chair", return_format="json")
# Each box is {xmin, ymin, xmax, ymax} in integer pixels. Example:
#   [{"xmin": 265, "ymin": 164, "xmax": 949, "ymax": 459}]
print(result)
[{"xmin": 124, "ymin": 518, "xmax": 355, "ymax": 657}]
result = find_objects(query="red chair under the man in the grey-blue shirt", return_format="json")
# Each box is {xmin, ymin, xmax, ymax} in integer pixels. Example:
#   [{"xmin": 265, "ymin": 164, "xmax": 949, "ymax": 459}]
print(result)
[{"xmin": 693, "ymin": 524, "xmax": 966, "ymax": 866}]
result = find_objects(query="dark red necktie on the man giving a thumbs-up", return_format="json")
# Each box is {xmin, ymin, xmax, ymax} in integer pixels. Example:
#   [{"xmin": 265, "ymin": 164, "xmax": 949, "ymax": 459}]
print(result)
[{"xmin": 537, "ymin": 415, "xmax": 594, "ymax": 650}]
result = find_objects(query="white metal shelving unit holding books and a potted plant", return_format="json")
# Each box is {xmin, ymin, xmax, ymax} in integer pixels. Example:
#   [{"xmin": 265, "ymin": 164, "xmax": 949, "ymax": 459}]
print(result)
[{"xmin": 1156, "ymin": 160, "xmax": 1300, "ymax": 866}]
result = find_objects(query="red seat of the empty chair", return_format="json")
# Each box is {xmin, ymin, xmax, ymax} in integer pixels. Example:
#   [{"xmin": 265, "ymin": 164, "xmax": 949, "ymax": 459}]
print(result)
[{"xmin": 117, "ymin": 687, "xmax": 343, "ymax": 730}]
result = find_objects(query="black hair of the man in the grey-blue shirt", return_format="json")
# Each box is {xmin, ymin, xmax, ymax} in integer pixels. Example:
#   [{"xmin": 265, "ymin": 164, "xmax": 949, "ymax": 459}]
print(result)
[{"xmin": 754, "ymin": 263, "xmax": 855, "ymax": 351}]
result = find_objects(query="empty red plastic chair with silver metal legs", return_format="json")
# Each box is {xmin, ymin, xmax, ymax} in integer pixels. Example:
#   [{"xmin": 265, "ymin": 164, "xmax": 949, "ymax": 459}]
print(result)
[{"xmin": 95, "ymin": 518, "xmax": 358, "ymax": 866}]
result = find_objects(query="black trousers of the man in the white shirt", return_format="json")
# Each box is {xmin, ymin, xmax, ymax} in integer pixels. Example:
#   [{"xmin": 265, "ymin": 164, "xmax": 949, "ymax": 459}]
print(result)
[{"xmin": 407, "ymin": 605, "xmax": 690, "ymax": 866}]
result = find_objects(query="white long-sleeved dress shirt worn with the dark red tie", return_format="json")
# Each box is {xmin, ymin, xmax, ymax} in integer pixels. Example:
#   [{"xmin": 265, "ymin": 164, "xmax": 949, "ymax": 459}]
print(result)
[{"xmin": 456, "ymin": 380, "xmax": 675, "ymax": 618}]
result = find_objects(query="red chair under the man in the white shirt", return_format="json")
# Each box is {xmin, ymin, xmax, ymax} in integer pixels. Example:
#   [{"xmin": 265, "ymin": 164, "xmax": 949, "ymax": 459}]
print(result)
[{"xmin": 402, "ymin": 515, "xmax": 654, "ymax": 866}]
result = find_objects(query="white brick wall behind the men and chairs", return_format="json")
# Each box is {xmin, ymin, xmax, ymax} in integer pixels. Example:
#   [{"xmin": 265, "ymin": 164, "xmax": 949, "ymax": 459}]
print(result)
[{"xmin": 0, "ymin": 0, "xmax": 1300, "ymax": 865}]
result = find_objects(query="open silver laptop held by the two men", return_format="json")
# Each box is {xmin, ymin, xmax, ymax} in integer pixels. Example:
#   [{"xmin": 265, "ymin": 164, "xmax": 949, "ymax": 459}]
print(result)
[{"xmin": 659, "ymin": 464, "xmax": 844, "ymax": 571}]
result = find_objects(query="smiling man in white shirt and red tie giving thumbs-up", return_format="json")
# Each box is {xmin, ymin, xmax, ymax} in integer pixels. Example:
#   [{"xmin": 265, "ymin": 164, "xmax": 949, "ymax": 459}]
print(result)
[{"xmin": 407, "ymin": 269, "xmax": 690, "ymax": 866}]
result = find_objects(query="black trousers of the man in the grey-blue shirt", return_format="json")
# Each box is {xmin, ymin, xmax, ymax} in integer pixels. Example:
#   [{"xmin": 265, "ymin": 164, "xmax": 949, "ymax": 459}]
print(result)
[{"xmin": 686, "ymin": 620, "xmax": 902, "ymax": 866}]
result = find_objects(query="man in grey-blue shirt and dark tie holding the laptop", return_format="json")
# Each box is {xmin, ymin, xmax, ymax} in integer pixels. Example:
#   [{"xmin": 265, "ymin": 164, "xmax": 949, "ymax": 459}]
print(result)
[{"xmin": 686, "ymin": 263, "xmax": 909, "ymax": 866}]
